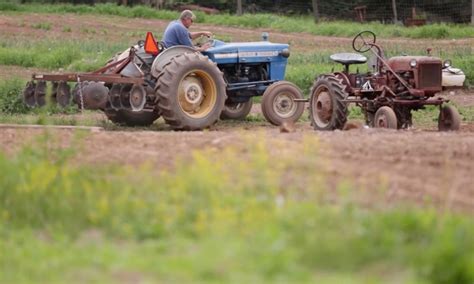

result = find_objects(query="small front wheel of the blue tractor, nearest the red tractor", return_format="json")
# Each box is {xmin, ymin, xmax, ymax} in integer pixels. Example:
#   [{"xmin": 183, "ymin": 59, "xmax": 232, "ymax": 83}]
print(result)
[{"xmin": 262, "ymin": 81, "xmax": 304, "ymax": 126}]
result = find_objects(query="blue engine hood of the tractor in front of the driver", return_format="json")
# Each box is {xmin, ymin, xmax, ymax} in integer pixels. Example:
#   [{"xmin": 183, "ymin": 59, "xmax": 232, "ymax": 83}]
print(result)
[{"xmin": 203, "ymin": 40, "xmax": 290, "ymax": 64}]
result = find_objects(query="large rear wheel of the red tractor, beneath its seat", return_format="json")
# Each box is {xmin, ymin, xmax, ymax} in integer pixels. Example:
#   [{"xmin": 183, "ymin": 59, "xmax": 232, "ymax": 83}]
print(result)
[{"xmin": 309, "ymin": 75, "xmax": 348, "ymax": 130}]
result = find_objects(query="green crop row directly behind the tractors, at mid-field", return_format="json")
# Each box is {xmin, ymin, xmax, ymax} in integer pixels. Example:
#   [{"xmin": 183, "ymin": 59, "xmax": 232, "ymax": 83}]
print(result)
[{"xmin": 0, "ymin": 38, "xmax": 474, "ymax": 93}]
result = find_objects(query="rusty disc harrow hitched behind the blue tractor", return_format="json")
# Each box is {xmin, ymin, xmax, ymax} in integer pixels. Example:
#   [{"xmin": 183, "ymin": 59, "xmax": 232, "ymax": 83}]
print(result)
[{"xmin": 23, "ymin": 47, "xmax": 146, "ymax": 111}]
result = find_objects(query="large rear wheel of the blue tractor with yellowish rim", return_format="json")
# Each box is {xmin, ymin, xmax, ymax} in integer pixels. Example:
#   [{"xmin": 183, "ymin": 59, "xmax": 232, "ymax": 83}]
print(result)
[{"xmin": 155, "ymin": 53, "xmax": 226, "ymax": 130}]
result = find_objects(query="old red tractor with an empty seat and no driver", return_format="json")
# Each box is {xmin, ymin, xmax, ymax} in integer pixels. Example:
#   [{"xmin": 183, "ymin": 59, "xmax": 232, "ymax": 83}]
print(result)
[{"xmin": 309, "ymin": 31, "xmax": 461, "ymax": 131}]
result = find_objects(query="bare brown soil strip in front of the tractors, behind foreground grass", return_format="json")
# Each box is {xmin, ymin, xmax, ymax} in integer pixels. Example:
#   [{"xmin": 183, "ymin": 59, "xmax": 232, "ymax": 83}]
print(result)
[{"xmin": 0, "ymin": 107, "xmax": 474, "ymax": 213}]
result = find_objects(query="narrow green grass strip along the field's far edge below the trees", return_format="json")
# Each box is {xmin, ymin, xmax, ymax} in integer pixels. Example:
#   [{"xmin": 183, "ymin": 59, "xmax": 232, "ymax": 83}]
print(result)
[{"xmin": 0, "ymin": 2, "xmax": 474, "ymax": 39}]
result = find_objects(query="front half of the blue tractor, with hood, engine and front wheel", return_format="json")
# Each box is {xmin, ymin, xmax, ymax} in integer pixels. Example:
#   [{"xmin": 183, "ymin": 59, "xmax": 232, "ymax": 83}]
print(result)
[{"xmin": 204, "ymin": 35, "xmax": 304, "ymax": 125}]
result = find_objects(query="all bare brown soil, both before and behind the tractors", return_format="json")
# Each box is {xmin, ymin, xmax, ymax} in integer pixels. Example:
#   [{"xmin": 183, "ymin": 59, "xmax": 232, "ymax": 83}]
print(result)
[{"xmin": 0, "ymin": 14, "xmax": 474, "ymax": 213}]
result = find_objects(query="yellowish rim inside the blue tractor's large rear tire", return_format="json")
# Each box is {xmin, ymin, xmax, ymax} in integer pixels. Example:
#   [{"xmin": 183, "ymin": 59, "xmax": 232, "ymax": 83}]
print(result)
[{"xmin": 178, "ymin": 71, "xmax": 217, "ymax": 118}]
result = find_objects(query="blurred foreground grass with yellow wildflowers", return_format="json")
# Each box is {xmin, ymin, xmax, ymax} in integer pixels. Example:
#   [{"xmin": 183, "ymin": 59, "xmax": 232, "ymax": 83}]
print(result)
[{"xmin": 0, "ymin": 133, "xmax": 474, "ymax": 284}]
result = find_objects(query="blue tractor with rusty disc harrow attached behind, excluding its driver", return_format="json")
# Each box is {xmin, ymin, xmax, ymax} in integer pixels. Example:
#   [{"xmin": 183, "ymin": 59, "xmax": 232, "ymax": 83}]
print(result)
[{"xmin": 23, "ymin": 33, "xmax": 304, "ymax": 130}]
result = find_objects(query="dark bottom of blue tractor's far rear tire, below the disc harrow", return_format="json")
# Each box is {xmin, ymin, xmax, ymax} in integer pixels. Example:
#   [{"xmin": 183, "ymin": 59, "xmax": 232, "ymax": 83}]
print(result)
[{"xmin": 104, "ymin": 109, "xmax": 160, "ymax": 126}]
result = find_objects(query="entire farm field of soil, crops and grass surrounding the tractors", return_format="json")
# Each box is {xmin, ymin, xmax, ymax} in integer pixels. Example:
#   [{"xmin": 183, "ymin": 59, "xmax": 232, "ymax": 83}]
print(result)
[{"xmin": 0, "ymin": 6, "xmax": 474, "ymax": 283}]
